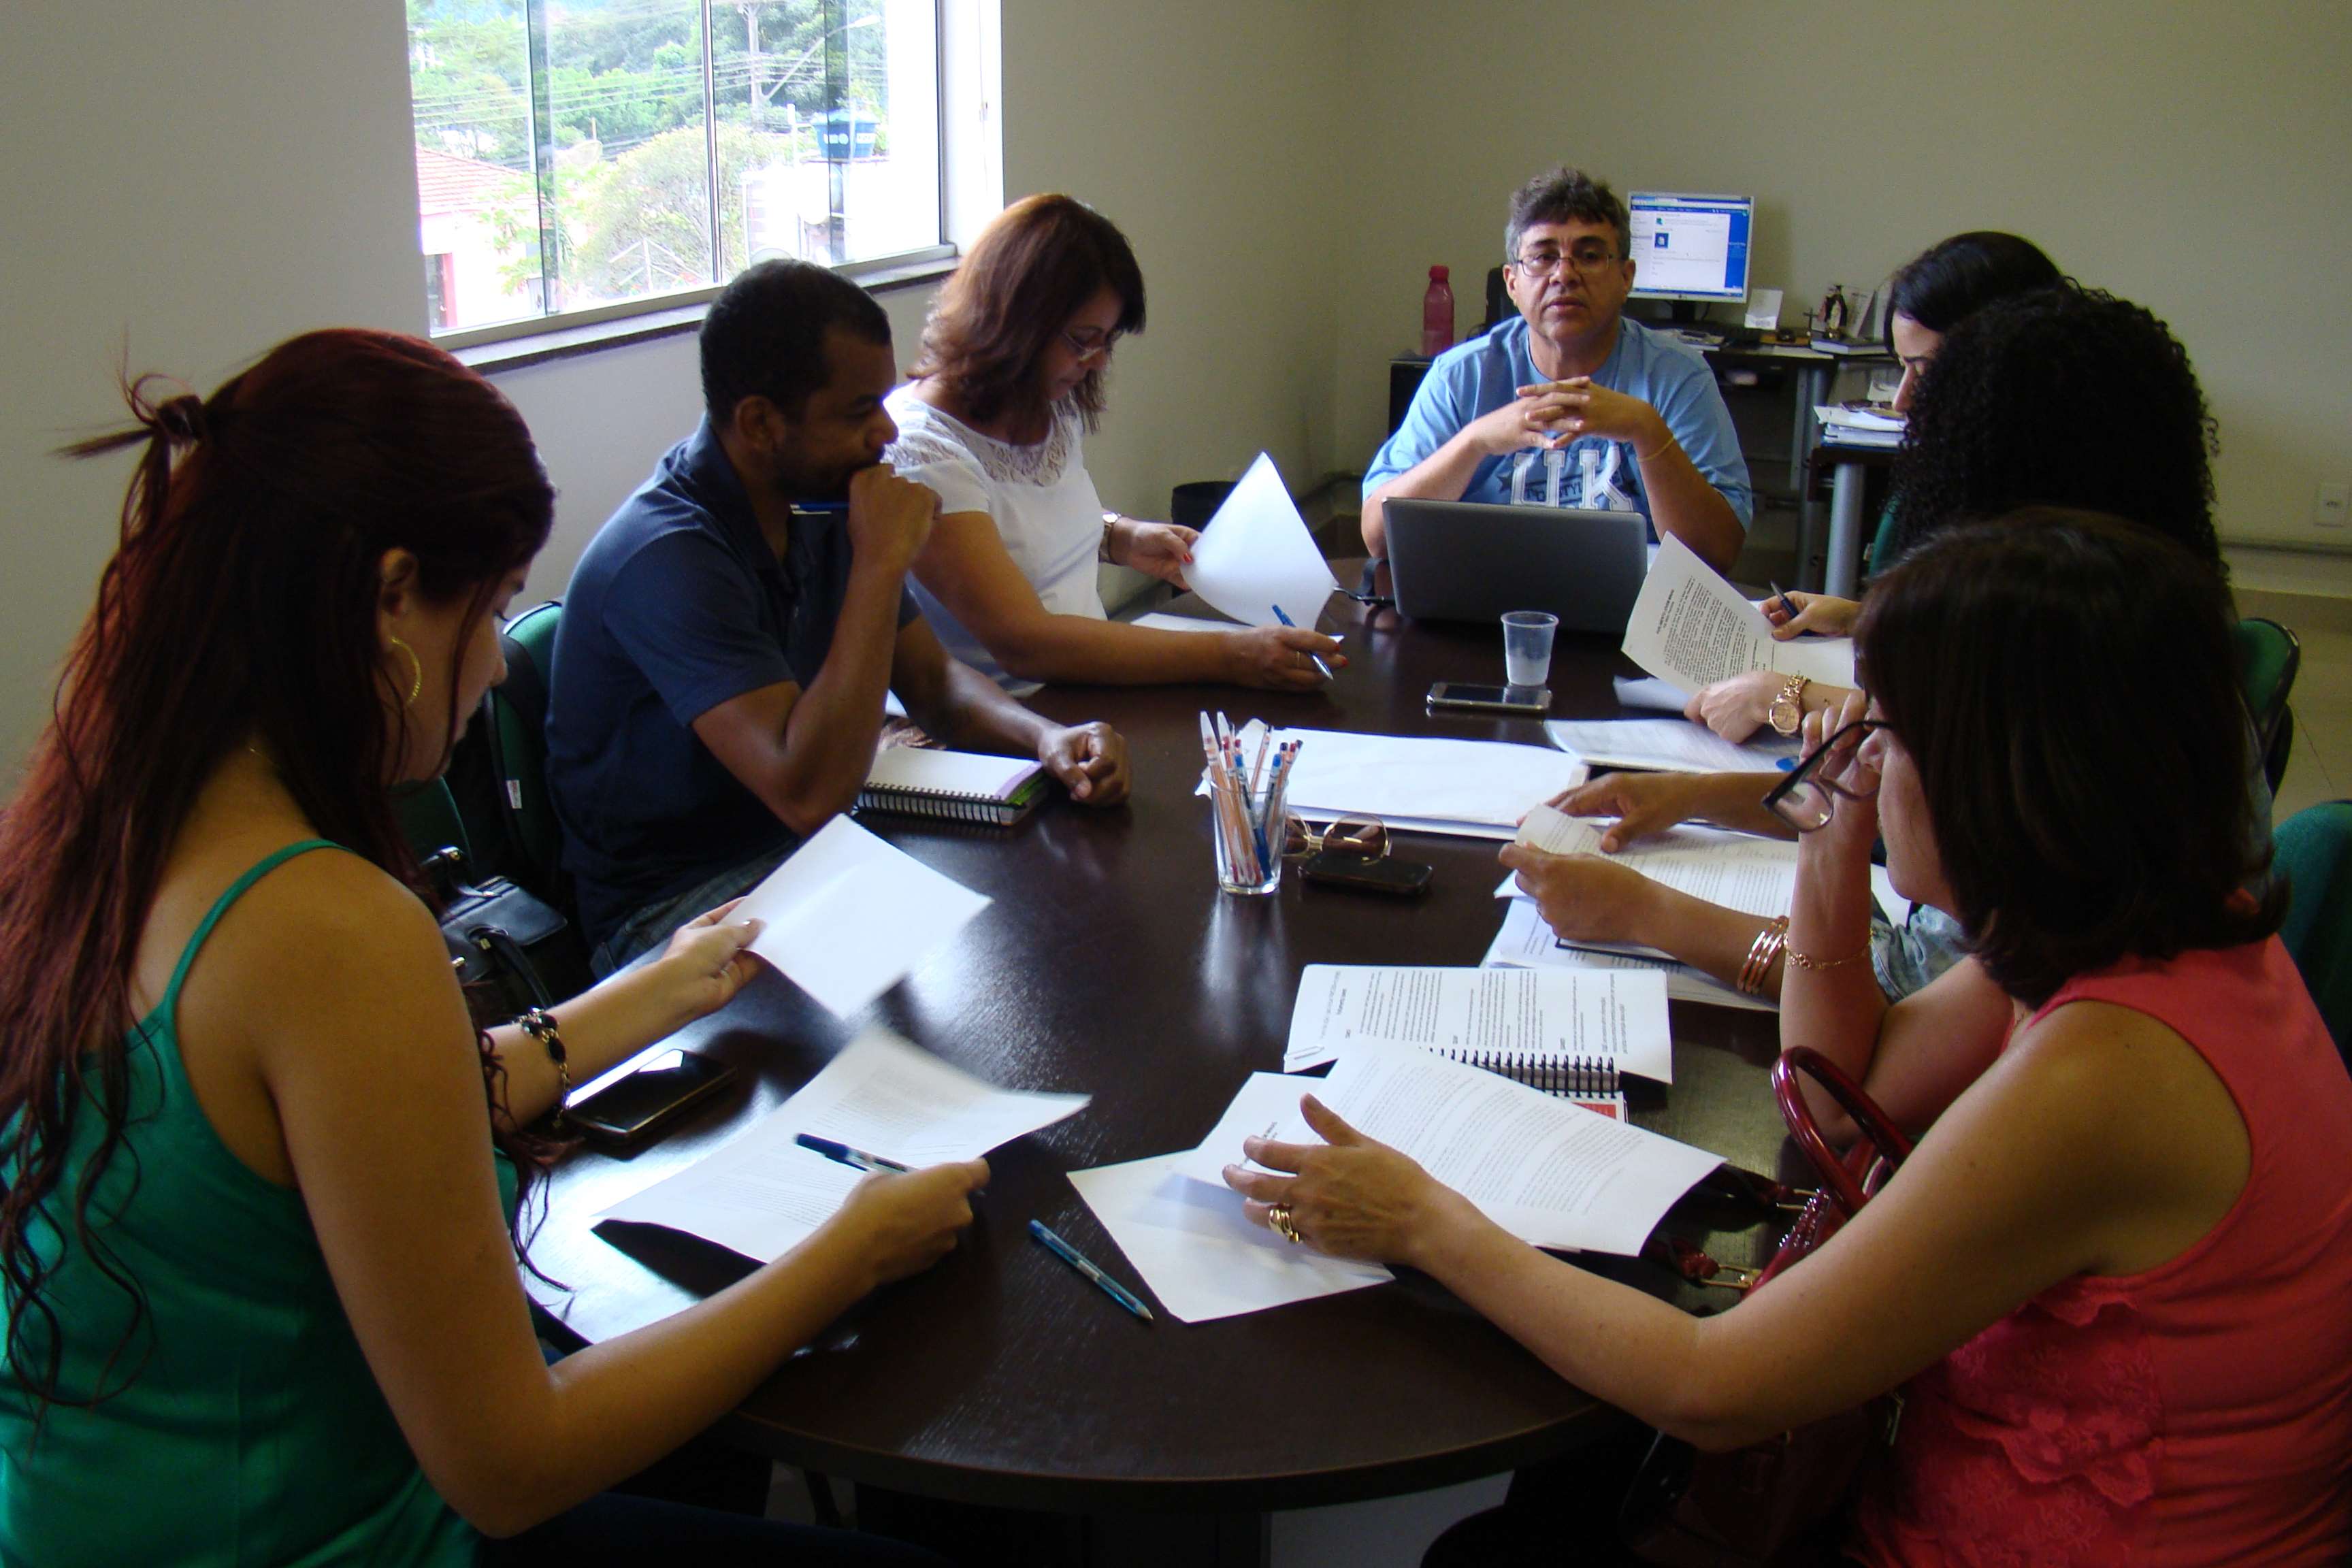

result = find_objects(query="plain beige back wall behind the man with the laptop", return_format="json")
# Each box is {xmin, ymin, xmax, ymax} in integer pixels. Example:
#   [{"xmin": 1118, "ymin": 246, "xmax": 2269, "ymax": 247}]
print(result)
[{"xmin": 1334, "ymin": 0, "xmax": 2352, "ymax": 545}]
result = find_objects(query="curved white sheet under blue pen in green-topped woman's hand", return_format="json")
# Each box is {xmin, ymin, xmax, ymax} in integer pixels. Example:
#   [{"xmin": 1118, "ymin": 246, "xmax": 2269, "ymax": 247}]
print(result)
[{"xmin": 598, "ymin": 1028, "xmax": 1089, "ymax": 1262}]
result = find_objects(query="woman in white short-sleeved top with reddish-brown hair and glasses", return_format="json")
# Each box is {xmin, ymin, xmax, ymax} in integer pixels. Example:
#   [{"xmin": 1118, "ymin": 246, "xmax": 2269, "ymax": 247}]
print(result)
[{"xmin": 884, "ymin": 195, "xmax": 1348, "ymax": 691}]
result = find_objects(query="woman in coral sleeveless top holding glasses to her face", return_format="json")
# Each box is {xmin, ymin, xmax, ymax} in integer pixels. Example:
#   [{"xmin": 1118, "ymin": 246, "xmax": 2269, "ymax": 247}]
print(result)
[{"xmin": 1226, "ymin": 512, "xmax": 2352, "ymax": 1566}]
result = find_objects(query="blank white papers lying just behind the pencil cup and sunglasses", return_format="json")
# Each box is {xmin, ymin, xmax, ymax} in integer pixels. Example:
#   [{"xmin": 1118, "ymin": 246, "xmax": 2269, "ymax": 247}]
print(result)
[{"xmin": 1244, "ymin": 729, "xmax": 1585, "ymax": 839}]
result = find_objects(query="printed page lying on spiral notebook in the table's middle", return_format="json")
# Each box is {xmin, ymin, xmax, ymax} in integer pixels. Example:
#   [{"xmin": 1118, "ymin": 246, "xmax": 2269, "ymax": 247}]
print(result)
[{"xmin": 1282, "ymin": 964, "xmax": 1675, "ymax": 1083}]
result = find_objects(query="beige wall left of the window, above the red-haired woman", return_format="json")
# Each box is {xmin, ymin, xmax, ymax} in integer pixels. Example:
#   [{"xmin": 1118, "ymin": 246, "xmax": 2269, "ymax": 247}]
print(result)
[{"xmin": 0, "ymin": 0, "xmax": 423, "ymax": 766}]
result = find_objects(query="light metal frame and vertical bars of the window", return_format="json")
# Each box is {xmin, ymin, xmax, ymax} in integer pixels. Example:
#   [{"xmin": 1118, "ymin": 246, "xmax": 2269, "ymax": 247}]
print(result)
[{"xmin": 409, "ymin": 0, "xmax": 960, "ymax": 353}]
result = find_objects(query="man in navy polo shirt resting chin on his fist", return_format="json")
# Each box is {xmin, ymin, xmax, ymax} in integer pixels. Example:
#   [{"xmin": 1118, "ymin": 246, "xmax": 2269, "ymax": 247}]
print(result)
[{"xmin": 548, "ymin": 261, "xmax": 1126, "ymax": 973}]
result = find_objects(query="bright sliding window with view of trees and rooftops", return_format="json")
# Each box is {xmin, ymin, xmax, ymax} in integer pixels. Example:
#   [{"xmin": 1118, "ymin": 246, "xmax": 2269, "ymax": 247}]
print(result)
[{"xmin": 407, "ymin": 0, "xmax": 945, "ymax": 336}]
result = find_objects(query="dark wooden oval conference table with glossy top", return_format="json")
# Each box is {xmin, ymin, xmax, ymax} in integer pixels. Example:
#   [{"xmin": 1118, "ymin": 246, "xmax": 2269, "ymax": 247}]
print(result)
[{"xmin": 532, "ymin": 581, "xmax": 1797, "ymax": 1540}]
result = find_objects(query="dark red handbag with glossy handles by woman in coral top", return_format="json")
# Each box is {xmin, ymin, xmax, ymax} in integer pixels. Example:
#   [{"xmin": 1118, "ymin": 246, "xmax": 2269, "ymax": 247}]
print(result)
[{"xmin": 1618, "ymin": 1046, "xmax": 1912, "ymax": 1568}]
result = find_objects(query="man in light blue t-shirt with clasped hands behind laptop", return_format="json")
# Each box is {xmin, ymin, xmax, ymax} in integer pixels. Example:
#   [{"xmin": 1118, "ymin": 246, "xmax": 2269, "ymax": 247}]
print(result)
[{"xmin": 1364, "ymin": 169, "xmax": 1754, "ymax": 571}]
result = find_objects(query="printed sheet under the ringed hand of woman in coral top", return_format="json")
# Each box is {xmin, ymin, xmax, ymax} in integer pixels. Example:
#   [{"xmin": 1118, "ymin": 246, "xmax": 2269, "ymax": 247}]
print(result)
[{"xmin": 1178, "ymin": 1041, "xmax": 1722, "ymax": 1256}]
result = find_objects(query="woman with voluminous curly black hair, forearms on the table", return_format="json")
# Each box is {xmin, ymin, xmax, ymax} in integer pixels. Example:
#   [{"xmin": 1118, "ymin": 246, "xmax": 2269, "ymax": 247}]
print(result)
[{"xmin": 1503, "ymin": 284, "xmax": 2230, "ymax": 997}]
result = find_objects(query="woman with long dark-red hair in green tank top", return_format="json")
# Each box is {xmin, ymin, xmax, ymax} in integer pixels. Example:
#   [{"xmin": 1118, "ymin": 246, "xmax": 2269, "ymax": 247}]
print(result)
[{"xmin": 0, "ymin": 331, "xmax": 983, "ymax": 1563}]
